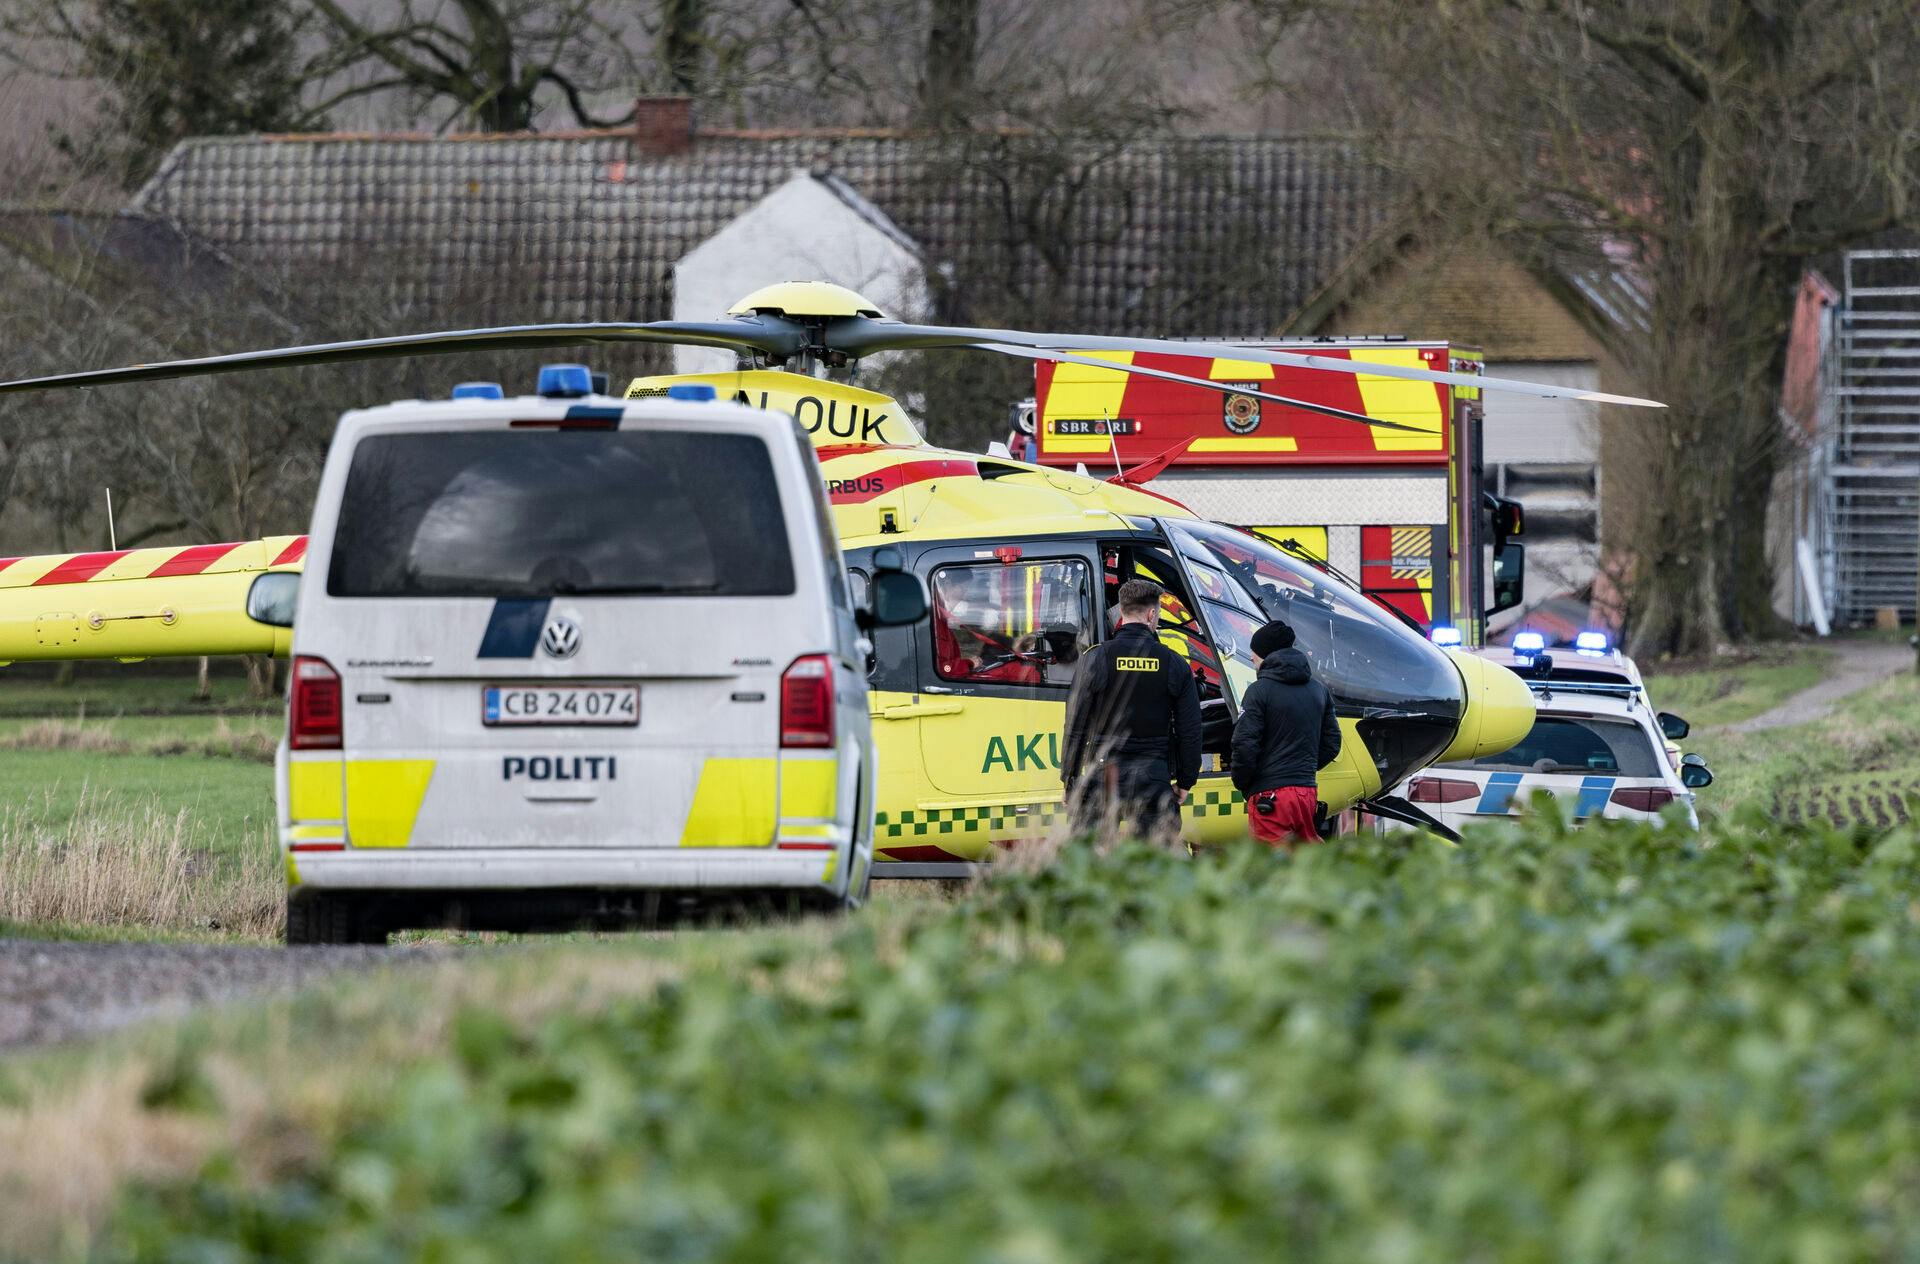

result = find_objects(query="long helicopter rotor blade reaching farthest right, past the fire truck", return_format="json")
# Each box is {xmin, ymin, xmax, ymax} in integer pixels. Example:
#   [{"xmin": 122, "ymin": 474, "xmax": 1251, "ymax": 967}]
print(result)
[{"xmin": 826, "ymin": 317, "xmax": 1667, "ymax": 407}]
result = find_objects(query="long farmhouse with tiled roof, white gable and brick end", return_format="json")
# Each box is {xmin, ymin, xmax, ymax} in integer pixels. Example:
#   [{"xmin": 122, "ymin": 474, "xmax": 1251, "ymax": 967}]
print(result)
[{"xmin": 120, "ymin": 100, "xmax": 1603, "ymax": 614}]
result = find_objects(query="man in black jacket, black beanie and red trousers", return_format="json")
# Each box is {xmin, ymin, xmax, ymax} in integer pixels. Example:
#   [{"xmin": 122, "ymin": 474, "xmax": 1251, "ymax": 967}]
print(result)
[{"xmin": 1233, "ymin": 619, "xmax": 1340, "ymax": 845}]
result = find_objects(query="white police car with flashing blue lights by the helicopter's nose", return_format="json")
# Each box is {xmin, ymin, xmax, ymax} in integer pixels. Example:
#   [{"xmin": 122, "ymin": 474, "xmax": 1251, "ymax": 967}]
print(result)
[{"xmin": 1402, "ymin": 632, "xmax": 1713, "ymax": 832}]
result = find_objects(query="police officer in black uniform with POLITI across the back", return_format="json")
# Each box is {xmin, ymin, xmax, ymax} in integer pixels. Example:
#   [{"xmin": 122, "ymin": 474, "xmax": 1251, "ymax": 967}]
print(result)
[{"xmin": 1060, "ymin": 580, "xmax": 1200, "ymax": 838}]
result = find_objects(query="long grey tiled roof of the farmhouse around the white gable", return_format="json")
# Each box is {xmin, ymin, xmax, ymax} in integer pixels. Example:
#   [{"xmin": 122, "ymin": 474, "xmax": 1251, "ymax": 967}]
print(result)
[{"xmin": 131, "ymin": 105, "xmax": 1386, "ymax": 334}]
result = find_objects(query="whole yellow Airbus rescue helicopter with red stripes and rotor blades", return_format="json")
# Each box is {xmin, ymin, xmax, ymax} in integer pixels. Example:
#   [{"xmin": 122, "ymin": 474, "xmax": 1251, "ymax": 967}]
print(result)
[{"xmin": 0, "ymin": 282, "xmax": 1659, "ymax": 866}]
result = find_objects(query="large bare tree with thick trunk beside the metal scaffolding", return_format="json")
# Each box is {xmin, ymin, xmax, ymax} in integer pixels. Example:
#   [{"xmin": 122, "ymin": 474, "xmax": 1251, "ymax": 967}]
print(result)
[{"xmin": 1256, "ymin": 0, "xmax": 1920, "ymax": 651}]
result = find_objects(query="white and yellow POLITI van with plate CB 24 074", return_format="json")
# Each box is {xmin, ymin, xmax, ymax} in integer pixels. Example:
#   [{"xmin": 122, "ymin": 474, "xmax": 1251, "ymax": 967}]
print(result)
[{"xmin": 261, "ymin": 365, "xmax": 925, "ymax": 943}]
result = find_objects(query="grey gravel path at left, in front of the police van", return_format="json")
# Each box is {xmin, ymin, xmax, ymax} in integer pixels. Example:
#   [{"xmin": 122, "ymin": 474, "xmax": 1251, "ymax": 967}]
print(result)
[{"xmin": 0, "ymin": 937, "xmax": 405, "ymax": 1053}]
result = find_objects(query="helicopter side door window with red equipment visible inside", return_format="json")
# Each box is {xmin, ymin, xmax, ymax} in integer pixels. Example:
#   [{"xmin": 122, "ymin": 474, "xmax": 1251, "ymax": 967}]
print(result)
[{"xmin": 933, "ymin": 561, "xmax": 1092, "ymax": 688}]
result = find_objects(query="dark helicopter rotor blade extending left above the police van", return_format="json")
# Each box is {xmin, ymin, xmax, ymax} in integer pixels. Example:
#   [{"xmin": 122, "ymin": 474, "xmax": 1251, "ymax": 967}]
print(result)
[{"xmin": 0, "ymin": 315, "xmax": 808, "ymax": 394}]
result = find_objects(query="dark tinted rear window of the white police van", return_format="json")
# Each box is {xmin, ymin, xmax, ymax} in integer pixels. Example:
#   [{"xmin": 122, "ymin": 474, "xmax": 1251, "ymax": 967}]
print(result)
[{"xmin": 326, "ymin": 430, "xmax": 793, "ymax": 597}]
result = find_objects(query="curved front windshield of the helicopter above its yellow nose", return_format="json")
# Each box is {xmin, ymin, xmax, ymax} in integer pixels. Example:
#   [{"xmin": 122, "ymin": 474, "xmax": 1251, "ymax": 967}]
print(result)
[{"xmin": 1165, "ymin": 521, "xmax": 1465, "ymax": 720}]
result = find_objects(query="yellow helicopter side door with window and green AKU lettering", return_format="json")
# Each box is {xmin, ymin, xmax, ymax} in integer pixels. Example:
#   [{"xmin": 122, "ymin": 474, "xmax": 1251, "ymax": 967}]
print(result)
[{"xmin": 898, "ymin": 538, "xmax": 1100, "ymax": 861}]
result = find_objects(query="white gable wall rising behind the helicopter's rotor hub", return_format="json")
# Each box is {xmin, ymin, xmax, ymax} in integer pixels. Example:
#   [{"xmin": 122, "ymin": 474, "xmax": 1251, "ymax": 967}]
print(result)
[{"xmin": 674, "ymin": 171, "xmax": 925, "ymax": 373}]
